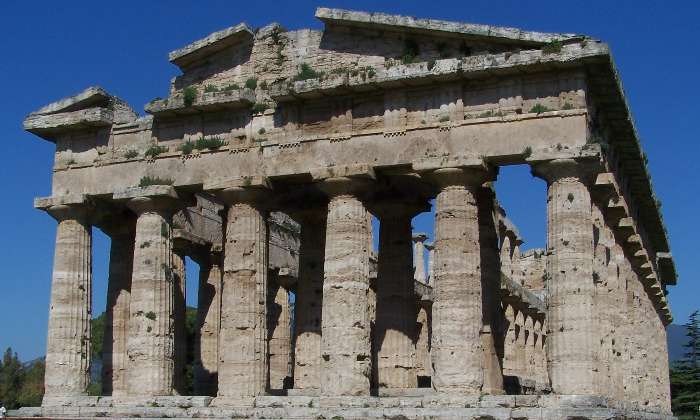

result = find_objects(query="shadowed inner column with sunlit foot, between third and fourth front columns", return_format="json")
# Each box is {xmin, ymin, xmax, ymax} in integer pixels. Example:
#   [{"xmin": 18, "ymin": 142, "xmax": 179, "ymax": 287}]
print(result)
[{"xmin": 293, "ymin": 205, "xmax": 328, "ymax": 390}]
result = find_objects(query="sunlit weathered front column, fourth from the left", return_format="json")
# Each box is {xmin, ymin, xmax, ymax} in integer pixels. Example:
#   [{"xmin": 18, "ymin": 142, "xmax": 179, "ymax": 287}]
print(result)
[{"xmin": 321, "ymin": 177, "xmax": 371, "ymax": 396}]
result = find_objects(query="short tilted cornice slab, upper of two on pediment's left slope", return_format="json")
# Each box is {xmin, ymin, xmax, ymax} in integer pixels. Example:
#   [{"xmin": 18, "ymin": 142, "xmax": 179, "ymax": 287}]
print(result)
[{"xmin": 168, "ymin": 23, "xmax": 255, "ymax": 69}]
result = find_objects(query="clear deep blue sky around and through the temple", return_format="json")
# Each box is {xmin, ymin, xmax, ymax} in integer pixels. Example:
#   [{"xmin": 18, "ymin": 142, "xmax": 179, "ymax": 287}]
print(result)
[{"xmin": 0, "ymin": 0, "xmax": 700, "ymax": 360}]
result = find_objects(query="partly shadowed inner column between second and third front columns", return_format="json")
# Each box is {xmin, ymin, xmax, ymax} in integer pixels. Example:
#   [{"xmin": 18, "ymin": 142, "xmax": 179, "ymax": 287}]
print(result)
[{"xmin": 194, "ymin": 254, "xmax": 221, "ymax": 396}]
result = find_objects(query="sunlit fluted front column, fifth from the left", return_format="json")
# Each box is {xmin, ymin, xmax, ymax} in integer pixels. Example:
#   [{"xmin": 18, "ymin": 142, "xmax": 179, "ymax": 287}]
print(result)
[{"xmin": 431, "ymin": 168, "xmax": 487, "ymax": 394}]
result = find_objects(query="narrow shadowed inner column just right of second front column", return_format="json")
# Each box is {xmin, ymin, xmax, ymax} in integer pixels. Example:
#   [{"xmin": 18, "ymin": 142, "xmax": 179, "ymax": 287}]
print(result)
[{"xmin": 173, "ymin": 252, "xmax": 187, "ymax": 395}]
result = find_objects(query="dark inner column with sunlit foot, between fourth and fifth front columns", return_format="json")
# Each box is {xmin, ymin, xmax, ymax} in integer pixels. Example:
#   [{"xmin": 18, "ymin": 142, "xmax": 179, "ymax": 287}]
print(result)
[{"xmin": 374, "ymin": 199, "xmax": 426, "ymax": 388}]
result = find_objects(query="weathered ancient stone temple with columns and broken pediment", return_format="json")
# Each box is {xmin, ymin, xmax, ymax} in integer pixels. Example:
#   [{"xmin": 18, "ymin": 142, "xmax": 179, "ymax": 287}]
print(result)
[{"xmin": 13, "ymin": 8, "xmax": 676, "ymax": 419}]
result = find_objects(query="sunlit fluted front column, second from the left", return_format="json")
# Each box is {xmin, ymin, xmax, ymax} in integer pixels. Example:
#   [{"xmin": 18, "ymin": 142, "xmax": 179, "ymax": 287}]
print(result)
[{"xmin": 123, "ymin": 186, "xmax": 183, "ymax": 397}]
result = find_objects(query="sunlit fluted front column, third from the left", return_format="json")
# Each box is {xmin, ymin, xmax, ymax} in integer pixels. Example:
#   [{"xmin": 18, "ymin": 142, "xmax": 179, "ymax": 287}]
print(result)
[{"xmin": 218, "ymin": 187, "xmax": 268, "ymax": 399}]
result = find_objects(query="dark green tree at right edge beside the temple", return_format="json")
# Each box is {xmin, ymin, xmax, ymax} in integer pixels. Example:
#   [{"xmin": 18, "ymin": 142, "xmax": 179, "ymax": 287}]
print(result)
[{"xmin": 670, "ymin": 311, "xmax": 700, "ymax": 419}]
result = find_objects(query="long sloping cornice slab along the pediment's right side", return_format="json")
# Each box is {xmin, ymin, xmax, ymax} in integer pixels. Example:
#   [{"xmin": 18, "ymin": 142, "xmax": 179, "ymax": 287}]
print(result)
[{"xmin": 316, "ymin": 7, "xmax": 586, "ymax": 46}]
